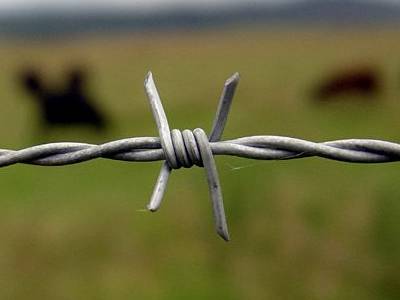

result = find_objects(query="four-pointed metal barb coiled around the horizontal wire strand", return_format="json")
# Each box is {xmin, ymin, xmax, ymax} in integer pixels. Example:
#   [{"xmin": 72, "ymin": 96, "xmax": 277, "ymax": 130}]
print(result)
[{"xmin": 144, "ymin": 72, "xmax": 239, "ymax": 241}]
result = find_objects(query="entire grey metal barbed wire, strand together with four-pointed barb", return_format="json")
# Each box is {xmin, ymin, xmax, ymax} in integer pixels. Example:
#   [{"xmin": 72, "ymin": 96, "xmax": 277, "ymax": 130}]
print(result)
[{"xmin": 0, "ymin": 72, "xmax": 400, "ymax": 241}]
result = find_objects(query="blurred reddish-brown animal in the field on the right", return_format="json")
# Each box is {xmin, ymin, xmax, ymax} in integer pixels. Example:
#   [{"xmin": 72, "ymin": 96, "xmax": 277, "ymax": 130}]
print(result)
[{"xmin": 314, "ymin": 67, "xmax": 380, "ymax": 101}]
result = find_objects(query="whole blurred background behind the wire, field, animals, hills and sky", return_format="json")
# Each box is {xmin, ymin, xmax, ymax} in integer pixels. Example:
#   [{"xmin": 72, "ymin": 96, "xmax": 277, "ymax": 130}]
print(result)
[{"xmin": 0, "ymin": 0, "xmax": 400, "ymax": 300}]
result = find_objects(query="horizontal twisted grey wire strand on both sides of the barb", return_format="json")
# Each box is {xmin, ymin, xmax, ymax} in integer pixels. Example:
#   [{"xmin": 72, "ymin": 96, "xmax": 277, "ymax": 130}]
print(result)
[{"xmin": 0, "ymin": 135, "xmax": 400, "ymax": 167}]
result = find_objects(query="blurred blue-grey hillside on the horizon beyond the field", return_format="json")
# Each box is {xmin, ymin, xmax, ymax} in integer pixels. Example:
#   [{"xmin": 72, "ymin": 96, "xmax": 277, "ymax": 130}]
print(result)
[{"xmin": 0, "ymin": 0, "xmax": 400, "ymax": 38}]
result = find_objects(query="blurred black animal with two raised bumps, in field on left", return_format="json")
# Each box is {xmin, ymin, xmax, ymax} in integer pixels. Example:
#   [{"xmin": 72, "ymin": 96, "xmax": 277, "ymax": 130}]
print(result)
[{"xmin": 19, "ymin": 68, "xmax": 105, "ymax": 130}]
